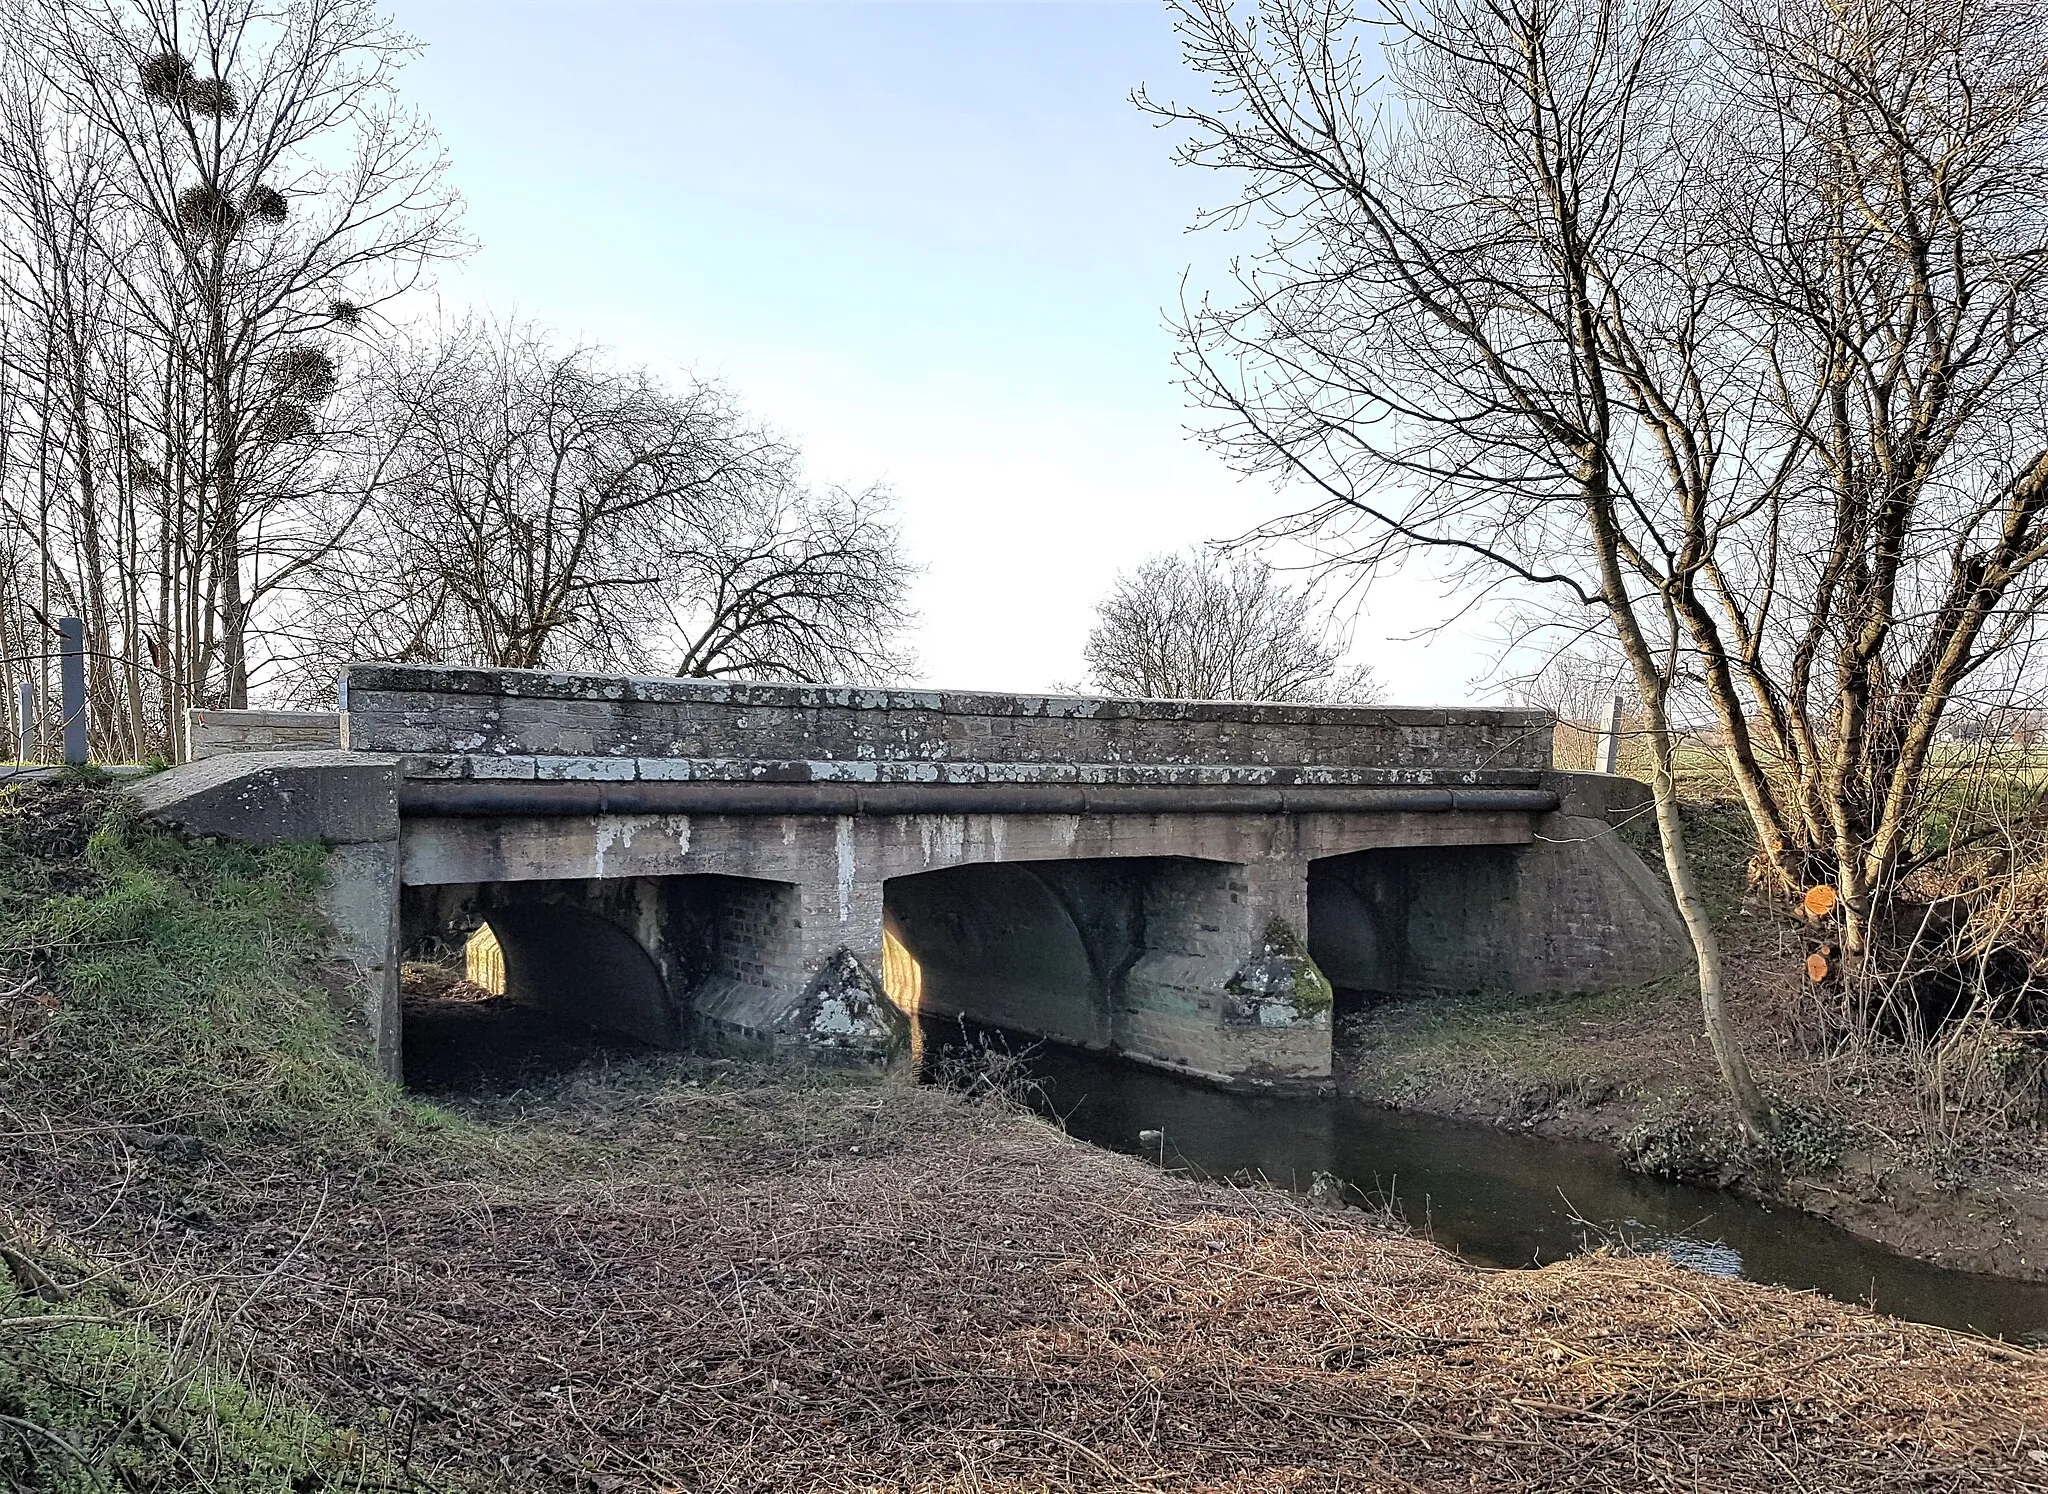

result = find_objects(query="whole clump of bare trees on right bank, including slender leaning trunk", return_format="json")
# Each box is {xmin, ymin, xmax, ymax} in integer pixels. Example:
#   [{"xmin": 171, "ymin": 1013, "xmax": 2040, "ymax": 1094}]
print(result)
[{"xmin": 1161, "ymin": 0, "xmax": 2048, "ymax": 1129}]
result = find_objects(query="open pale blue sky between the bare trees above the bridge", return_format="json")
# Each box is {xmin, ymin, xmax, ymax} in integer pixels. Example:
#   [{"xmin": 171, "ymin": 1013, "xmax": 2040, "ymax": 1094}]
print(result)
[{"xmin": 391, "ymin": 0, "xmax": 1491, "ymax": 705}]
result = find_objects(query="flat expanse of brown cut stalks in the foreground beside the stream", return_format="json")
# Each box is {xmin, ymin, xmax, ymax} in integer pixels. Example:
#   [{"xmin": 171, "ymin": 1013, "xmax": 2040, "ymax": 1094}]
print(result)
[{"xmin": 24, "ymin": 1064, "xmax": 2048, "ymax": 1494}]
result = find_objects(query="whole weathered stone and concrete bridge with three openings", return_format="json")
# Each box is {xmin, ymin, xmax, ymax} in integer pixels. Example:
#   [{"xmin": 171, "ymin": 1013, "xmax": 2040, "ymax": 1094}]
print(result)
[{"xmin": 135, "ymin": 664, "xmax": 1686, "ymax": 1082}]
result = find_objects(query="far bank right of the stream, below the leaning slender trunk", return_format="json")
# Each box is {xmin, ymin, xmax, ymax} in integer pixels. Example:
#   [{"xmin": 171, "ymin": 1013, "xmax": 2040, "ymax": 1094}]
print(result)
[{"xmin": 1337, "ymin": 799, "xmax": 2048, "ymax": 1281}]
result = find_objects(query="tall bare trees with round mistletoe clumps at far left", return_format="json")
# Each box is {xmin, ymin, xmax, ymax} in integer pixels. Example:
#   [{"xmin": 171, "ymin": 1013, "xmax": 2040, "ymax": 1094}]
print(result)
[{"xmin": 0, "ymin": 0, "xmax": 461, "ymax": 752}]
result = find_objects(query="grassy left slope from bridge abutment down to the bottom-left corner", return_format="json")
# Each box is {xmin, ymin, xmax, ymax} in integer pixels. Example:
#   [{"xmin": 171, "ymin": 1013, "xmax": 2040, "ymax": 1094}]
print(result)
[{"xmin": 0, "ymin": 779, "xmax": 450, "ymax": 1494}]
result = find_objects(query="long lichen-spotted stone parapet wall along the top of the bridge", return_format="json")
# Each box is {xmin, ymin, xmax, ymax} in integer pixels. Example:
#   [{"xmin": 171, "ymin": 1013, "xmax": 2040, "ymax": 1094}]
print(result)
[{"xmin": 342, "ymin": 664, "xmax": 1552, "ymax": 777}]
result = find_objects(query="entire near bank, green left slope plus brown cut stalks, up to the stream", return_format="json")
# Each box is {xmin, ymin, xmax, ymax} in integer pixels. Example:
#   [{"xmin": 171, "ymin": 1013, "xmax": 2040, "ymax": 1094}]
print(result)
[{"xmin": 0, "ymin": 799, "xmax": 2048, "ymax": 1494}]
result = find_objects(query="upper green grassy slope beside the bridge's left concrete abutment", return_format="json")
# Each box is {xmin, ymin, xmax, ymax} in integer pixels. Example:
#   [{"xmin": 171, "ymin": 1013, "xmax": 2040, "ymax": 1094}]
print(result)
[{"xmin": 0, "ymin": 785, "xmax": 418, "ymax": 1156}]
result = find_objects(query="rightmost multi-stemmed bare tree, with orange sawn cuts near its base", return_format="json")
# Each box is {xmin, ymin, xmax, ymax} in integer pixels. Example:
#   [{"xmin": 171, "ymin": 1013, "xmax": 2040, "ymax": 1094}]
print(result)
[{"xmin": 1683, "ymin": 0, "xmax": 2048, "ymax": 953}]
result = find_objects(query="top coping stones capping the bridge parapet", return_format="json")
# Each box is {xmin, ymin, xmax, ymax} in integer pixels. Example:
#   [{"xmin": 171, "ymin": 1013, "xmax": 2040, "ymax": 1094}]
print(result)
[{"xmin": 340, "ymin": 664, "xmax": 1552, "ymax": 730}]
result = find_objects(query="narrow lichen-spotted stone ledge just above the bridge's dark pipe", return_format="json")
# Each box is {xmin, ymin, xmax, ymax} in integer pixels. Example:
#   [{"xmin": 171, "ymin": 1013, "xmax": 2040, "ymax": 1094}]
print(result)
[{"xmin": 399, "ymin": 752, "xmax": 1544, "ymax": 789}]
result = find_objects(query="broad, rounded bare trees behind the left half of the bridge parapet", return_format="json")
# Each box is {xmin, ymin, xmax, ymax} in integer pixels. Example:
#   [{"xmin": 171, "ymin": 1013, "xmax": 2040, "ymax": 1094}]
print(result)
[{"xmin": 276, "ymin": 322, "xmax": 909, "ymax": 697}]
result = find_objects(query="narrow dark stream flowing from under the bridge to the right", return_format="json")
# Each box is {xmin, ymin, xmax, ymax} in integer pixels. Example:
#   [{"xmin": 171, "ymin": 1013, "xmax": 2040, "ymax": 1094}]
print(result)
[{"xmin": 926, "ymin": 1023, "xmax": 2048, "ymax": 1342}]
